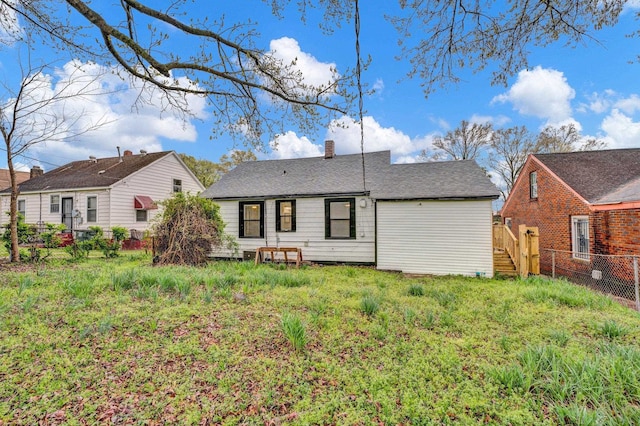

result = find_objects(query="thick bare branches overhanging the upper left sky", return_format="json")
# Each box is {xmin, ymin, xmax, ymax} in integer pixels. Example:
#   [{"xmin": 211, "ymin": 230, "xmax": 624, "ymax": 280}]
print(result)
[{"xmin": 0, "ymin": 0, "xmax": 353, "ymax": 146}]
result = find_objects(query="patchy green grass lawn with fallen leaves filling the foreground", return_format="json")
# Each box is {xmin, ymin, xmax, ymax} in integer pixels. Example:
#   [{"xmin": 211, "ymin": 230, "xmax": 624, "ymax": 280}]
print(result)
[{"xmin": 0, "ymin": 253, "xmax": 640, "ymax": 425}]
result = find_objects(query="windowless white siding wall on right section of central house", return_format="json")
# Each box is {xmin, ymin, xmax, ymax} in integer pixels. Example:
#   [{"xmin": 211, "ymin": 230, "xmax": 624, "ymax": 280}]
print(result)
[{"xmin": 377, "ymin": 200, "xmax": 493, "ymax": 277}]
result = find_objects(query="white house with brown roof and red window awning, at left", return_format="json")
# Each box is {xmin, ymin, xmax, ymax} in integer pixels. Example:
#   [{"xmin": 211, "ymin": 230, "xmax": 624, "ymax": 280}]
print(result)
[{"xmin": 0, "ymin": 151, "xmax": 204, "ymax": 235}]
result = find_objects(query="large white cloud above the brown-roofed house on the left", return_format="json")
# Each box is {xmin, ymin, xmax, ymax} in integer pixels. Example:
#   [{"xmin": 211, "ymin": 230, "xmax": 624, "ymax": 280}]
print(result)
[{"xmin": 10, "ymin": 61, "xmax": 206, "ymax": 169}]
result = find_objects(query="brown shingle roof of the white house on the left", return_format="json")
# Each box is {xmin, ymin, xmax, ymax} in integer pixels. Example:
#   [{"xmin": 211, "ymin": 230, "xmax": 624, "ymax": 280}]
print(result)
[{"xmin": 0, "ymin": 151, "xmax": 173, "ymax": 193}]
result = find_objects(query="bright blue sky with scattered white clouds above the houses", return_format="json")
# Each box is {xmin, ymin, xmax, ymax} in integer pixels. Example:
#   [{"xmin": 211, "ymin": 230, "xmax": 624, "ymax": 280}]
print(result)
[{"xmin": 0, "ymin": 0, "xmax": 640, "ymax": 171}]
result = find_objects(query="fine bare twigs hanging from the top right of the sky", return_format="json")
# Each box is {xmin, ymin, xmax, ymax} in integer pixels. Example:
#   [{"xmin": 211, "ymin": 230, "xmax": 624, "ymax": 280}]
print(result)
[{"xmin": 390, "ymin": 0, "xmax": 627, "ymax": 94}]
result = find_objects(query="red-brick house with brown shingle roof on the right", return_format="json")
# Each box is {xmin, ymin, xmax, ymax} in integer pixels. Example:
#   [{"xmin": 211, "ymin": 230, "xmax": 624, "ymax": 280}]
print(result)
[{"xmin": 501, "ymin": 148, "xmax": 640, "ymax": 272}]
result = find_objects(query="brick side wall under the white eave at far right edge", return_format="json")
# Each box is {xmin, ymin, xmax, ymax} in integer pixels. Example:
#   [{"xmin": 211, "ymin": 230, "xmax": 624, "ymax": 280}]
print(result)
[{"xmin": 589, "ymin": 209, "xmax": 640, "ymax": 255}]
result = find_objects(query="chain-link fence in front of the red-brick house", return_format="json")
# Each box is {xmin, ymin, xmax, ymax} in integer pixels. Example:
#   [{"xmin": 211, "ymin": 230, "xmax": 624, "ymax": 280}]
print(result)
[{"xmin": 540, "ymin": 249, "xmax": 640, "ymax": 311}]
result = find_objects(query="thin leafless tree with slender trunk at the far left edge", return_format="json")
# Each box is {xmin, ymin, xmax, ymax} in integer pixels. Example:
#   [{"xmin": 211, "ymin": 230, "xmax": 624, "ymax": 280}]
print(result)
[{"xmin": 0, "ymin": 55, "xmax": 107, "ymax": 262}]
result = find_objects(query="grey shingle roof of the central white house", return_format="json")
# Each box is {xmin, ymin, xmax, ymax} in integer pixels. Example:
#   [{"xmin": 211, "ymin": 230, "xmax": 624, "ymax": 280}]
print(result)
[{"xmin": 202, "ymin": 151, "xmax": 499, "ymax": 200}]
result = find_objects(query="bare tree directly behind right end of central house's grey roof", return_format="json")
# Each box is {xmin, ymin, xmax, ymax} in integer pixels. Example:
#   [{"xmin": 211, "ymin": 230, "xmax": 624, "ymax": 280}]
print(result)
[{"xmin": 433, "ymin": 120, "xmax": 492, "ymax": 160}]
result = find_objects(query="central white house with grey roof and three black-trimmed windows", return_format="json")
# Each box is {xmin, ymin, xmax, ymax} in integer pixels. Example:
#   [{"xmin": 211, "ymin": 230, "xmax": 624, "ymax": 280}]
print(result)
[{"xmin": 202, "ymin": 141, "xmax": 499, "ymax": 276}]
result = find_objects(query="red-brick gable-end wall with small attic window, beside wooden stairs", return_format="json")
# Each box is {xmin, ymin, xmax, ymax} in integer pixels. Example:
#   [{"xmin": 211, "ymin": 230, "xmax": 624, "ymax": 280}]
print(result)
[{"xmin": 502, "ymin": 159, "xmax": 594, "ymax": 253}]
